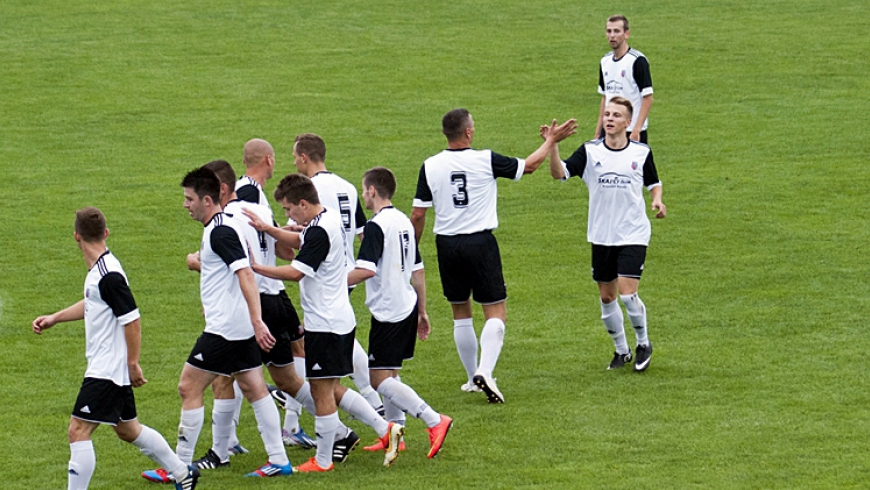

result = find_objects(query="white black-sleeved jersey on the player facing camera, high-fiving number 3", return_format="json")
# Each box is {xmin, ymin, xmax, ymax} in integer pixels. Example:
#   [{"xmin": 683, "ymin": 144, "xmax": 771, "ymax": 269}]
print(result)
[{"xmin": 562, "ymin": 139, "xmax": 661, "ymax": 246}]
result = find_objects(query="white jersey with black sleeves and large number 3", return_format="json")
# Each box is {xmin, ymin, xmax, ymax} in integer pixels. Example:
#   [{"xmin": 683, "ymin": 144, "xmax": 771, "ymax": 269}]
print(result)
[{"xmin": 414, "ymin": 148, "xmax": 525, "ymax": 235}]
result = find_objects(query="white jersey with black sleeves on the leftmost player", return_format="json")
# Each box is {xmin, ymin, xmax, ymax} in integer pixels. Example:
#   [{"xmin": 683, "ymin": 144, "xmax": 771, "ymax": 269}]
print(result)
[{"xmin": 84, "ymin": 250, "xmax": 139, "ymax": 386}]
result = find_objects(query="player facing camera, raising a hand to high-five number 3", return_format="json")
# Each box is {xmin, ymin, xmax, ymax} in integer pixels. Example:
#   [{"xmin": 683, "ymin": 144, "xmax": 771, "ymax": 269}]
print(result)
[{"xmin": 541, "ymin": 97, "xmax": 667, "ymax": 372}]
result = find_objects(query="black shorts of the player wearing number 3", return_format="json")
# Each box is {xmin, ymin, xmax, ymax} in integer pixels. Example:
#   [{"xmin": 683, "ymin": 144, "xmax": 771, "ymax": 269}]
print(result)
[{"xmin": 435, "ymin": 230, "xmax": 507, "ymax": 305}]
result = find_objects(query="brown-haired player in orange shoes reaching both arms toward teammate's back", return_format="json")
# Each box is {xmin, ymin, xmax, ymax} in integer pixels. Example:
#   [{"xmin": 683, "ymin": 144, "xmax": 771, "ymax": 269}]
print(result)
[{"xmin": 245, "ymin": 174, "xmax": 404, "ymax": 472}]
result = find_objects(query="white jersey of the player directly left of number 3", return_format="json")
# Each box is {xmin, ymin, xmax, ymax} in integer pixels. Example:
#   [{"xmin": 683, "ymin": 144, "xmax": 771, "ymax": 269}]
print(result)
[{"xmin": 356, "ymin": 206, "xmax": 423, "ymax": 323}]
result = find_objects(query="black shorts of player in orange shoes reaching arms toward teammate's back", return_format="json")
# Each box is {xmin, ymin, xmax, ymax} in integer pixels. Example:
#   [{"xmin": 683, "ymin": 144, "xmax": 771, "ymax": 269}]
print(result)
[{"xmin": 305, "ymin": 329, "xmax": 356, "ymax": 379}]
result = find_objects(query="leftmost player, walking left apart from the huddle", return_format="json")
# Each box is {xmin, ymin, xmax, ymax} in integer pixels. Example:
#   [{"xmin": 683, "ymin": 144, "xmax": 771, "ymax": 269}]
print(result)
[{"xmin": 32, "ymin": 207, "xmax": 199, "ymax": 490}]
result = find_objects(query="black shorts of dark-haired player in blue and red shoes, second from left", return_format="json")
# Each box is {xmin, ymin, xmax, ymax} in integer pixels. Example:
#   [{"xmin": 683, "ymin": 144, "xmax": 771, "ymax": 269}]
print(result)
[{"xmin": 187, "ymin": 332, "xmax": 262, "ymax": 376}]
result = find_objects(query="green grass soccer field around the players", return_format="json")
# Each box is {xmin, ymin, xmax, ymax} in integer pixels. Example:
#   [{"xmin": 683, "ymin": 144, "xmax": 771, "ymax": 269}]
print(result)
[{"xmin": 0, "ymin": 0, "xmax": 870, "ymax": 489}]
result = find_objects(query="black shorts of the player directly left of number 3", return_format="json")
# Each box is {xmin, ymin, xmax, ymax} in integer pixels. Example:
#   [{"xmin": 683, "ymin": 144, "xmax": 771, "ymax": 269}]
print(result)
[{"xmin": 369, "ymin": 305, "xmax": 417, "ymax": 369}]
